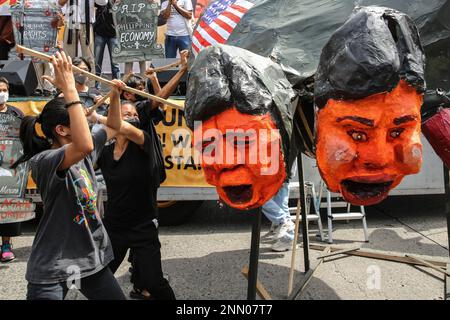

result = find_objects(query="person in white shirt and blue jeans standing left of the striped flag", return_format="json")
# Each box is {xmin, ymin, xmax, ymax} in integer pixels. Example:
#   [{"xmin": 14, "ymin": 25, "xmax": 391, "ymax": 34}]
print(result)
[{"xmin": 161, "ymin": 0, "xmax": 193, "ymax": 58}]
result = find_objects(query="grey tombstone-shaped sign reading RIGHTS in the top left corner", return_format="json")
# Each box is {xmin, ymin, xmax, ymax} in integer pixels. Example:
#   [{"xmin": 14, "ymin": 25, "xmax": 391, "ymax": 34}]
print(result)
[{"xmin": 11, "ymin": 0, "xmax": 59, "ymax": 54}]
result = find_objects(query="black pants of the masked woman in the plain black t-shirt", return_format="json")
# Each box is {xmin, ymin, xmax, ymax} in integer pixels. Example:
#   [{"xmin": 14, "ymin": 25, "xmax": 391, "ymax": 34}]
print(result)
[{"xmin": 105, "ymin": 223, "xmax": 175, "ymax": 300}]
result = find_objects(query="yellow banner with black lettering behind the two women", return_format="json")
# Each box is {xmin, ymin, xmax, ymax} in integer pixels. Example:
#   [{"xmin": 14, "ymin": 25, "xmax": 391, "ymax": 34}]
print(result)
[{"xmin": 8, "ymin": 100, "xmax": 211, "ymax": 189}]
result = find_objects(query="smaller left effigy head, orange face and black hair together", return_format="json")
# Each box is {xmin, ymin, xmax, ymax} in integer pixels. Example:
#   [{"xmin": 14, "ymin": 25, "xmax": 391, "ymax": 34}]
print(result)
[{"xmin": 185, "ymin": 45, "xmax": 295, "ymax": 210}]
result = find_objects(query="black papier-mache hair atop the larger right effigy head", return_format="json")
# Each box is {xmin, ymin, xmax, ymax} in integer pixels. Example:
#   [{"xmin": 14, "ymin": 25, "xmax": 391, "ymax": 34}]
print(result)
[{"xmin": 314, "ymin": 7, "xmax": 425, "ymax": 108}]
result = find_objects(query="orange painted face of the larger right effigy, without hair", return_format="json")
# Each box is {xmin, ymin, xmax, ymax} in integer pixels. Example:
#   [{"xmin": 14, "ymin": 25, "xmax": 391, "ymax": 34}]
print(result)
[{"xmin": 316, "ymin": 80, "xmax": 423, "ymax": 205}]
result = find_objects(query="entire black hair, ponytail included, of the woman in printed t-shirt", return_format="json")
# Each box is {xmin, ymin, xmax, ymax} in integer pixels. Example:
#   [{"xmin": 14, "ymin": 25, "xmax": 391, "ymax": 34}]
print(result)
[{"xmin": 11, "ymin": 98, "xmax": 70, "ymax": 169}]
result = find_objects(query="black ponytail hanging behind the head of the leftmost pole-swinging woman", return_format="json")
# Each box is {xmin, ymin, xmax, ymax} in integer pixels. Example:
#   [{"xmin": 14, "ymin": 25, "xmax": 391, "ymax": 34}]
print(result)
[{"xmin": 11, "ymin": 116, "xmax": 51, "ymax": 169}]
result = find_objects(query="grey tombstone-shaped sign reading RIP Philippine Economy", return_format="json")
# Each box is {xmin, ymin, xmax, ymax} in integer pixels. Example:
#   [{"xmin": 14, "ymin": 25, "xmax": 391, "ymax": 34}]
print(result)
[{"xmin": 112, "ymin": 0, "xmax": 164, "ymax": 62}]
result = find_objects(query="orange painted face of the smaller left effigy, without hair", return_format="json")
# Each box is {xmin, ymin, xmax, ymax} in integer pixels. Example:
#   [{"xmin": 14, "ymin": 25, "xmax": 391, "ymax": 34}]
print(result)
[{"xmin": 194, "ymin": 108, "xmax": 286, "ymax": 210}]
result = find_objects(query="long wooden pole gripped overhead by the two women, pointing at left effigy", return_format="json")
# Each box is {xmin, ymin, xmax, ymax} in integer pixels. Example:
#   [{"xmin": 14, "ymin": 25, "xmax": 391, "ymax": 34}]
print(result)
[{"xmin": 16, "ymin": 45, "xmax": 184, "ymax": 110}]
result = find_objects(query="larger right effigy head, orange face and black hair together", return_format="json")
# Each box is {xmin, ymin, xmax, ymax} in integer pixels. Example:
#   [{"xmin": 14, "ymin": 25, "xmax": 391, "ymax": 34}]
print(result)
[{"xmin": 314, "ymin": 7, "xmax": 425, "ymax": 205}]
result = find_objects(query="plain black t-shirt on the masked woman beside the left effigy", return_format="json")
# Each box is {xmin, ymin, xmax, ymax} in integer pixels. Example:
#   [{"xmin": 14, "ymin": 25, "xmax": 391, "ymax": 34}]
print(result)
[{"xmin": 97, "ymin": 131, "xmax": 158, "ymax": 229}]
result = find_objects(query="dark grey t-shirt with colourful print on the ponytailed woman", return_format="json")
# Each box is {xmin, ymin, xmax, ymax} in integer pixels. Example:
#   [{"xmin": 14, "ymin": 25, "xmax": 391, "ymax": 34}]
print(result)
[{"xmin": 25, "ymin": 128, "xmax": 113, "ymax": 284}]
